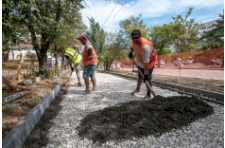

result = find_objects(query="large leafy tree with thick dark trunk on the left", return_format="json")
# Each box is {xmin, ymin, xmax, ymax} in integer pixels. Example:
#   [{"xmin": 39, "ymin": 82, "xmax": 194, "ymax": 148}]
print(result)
[{"xmin": 3, "ymin": 0, "xmax": 83, "ymax": 74}]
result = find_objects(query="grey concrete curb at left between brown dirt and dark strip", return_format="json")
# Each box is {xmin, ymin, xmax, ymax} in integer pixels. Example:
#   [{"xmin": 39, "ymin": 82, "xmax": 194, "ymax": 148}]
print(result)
[{"xmin": 2, "ymin": 84, "xmax": 61, "ymax": 148}]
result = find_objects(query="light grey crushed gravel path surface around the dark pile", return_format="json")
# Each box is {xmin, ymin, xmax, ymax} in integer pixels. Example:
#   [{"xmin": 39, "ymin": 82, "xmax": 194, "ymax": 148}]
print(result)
[{"xmin": 24, "ymin": 73, "xmax": 224, "ymax": 148}]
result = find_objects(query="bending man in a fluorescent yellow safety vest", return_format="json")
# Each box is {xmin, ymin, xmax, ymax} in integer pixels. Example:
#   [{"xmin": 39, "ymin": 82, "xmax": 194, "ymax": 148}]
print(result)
[{"xmin": 58, "ymin": 47, "xmax": 82, "ymax": 87}]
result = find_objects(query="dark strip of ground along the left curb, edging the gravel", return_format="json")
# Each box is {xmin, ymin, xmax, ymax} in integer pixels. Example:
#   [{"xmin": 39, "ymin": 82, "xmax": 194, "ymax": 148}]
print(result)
[{"xmin": 23, "ymin": 89, "xmax": 67, "ymax": 148}]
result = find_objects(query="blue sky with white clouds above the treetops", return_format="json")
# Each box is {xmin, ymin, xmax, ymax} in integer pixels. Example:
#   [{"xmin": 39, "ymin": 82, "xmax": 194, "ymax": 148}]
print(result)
[{"xmin": 81, "ymin": 0, "xmax": 224, "ymax": 32}]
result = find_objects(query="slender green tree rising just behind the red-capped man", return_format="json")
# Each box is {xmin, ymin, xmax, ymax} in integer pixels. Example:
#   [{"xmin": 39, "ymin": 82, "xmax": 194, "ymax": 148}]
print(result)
[{"xmin": 87, "ymin": 18, "xmax": 106, "ymax": 54}]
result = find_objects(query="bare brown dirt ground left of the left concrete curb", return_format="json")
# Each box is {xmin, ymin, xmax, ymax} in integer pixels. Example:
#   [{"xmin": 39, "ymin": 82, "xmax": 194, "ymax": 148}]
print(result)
[{"xmin": 2, "ymin": 71, "xmax": 70, "ymax": 138}]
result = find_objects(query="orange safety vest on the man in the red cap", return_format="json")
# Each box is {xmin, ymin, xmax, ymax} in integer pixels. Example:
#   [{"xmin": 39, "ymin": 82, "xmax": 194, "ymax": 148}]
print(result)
[{"xmin": 83, "ymin": 43, "xmax": 98, "ymax": 67}]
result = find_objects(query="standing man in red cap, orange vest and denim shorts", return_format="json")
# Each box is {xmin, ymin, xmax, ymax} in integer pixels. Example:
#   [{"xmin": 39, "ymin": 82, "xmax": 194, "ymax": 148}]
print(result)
[{"xmin": 77, "ymin": 35, "xmax": 98, "ymax": 93}]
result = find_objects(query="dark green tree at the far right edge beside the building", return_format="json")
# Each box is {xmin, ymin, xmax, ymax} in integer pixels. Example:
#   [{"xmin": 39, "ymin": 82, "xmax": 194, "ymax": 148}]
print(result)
[{"xmin": 200, "ymin": 14, "xmax": 224, "ymax": 48}]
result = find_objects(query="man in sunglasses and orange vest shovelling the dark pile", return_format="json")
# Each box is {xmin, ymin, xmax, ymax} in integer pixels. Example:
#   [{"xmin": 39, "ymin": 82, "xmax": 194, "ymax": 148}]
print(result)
[{"xmin": 129, "ymin": 29, "xmax": 157, "ymax": 101}]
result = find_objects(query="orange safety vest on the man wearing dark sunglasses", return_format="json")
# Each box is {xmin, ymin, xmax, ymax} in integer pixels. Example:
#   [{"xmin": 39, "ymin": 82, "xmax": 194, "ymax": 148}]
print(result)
[{"xmin": 131, "ymin": 37, "xmax": 157, "ymax": 69}]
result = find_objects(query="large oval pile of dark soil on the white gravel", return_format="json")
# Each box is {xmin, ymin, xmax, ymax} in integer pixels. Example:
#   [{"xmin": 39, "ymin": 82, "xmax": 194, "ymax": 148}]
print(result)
[{"xmin": 77, "ymin": 96, "xmax": 213, "ymax": 143}]
